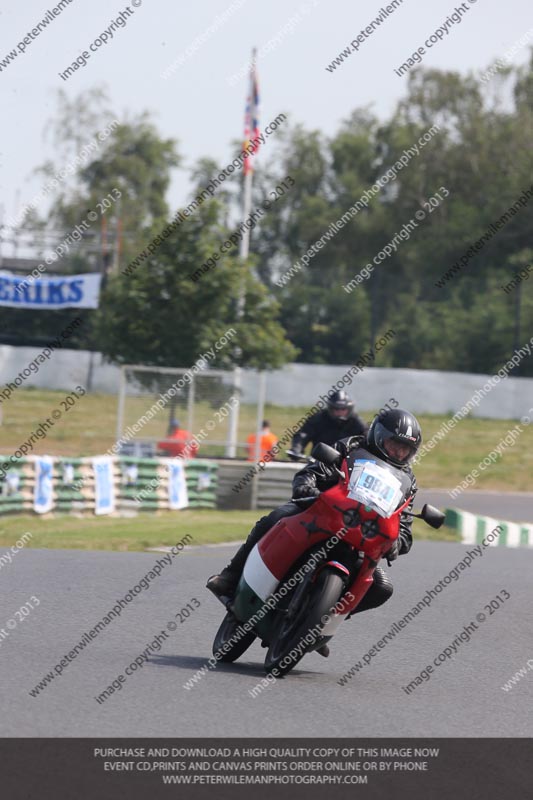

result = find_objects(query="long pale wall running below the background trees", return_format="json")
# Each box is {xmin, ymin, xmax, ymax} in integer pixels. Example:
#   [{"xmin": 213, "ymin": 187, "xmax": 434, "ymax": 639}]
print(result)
[{"xmin": 0, "ymin": 345, "xmax": 533, "ymax": 419}]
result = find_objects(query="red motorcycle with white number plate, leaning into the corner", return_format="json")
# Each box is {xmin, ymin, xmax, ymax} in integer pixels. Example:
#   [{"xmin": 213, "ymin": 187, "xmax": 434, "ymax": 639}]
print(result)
[{"xmin": 213, "ymin": 444, "xmax": 445, "ymax": 677}]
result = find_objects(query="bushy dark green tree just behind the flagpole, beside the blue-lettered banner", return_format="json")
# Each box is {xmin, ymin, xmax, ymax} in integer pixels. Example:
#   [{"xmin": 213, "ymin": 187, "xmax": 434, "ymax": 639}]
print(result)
[{"xmin": 98, "ymin": 200, "xmax": 295, "ymax": 369}]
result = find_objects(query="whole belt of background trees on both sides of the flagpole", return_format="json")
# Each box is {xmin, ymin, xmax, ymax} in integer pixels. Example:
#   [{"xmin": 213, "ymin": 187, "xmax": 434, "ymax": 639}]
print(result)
[{"xmin": 4, "ymin": 52, "xmax": 533, "ymax": 375}]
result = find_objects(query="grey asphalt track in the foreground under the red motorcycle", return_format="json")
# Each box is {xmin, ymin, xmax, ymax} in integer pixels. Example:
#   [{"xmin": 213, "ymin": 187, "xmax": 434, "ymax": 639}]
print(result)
[{"xmin": 0, "ymin": 542, "xmax": 533, "ymax": 737}]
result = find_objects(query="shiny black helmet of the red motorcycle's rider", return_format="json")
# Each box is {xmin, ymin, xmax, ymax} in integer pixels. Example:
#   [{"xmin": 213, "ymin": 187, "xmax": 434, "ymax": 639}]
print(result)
[{"xmin": 367, "ymin": 408, "xmax": 422, "ymax": 467}]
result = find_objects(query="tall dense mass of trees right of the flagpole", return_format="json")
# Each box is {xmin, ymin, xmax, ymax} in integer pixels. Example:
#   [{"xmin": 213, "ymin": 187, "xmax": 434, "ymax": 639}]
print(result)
[{"xmin": 250, "ymin": 55, "xmax": 533, "ymax": 374}]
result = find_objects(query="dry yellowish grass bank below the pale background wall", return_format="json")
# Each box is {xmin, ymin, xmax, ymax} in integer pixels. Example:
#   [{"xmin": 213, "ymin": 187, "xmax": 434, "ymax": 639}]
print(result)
[{"xmin": 0, "ymin": 389, "xmax": 533, "ymax": 491}]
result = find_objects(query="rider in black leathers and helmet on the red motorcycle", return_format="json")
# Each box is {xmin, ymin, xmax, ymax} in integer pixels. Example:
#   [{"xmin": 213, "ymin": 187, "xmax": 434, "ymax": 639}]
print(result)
[{"xmin": 207, "ymin": 408, "xmax": 422, "ymax": 636}]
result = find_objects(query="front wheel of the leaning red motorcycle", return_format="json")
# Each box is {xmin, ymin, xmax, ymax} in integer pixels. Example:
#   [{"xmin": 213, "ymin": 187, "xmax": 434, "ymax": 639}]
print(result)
[{"xmin": 265, "ymin": 569, "xmax": 344, "ymax": 678}]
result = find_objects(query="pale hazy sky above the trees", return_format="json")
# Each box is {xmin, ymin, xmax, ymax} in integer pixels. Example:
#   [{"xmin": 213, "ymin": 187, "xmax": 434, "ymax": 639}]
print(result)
[{"xmin": 0, "ymin": 0, "xmax": 533, "ymax": 255}]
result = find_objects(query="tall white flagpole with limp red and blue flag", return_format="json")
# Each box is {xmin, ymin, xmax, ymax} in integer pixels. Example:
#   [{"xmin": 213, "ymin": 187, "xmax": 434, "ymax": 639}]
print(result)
[{"xmin": 226, "ymin": 47, "xmax": 257, "ymax": 458}]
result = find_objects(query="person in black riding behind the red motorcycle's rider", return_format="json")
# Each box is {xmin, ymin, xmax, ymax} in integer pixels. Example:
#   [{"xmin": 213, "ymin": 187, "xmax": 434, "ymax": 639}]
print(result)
[{"xmin": 288, "ymin": 389, "xmax": 368, "ymax": 460}]
